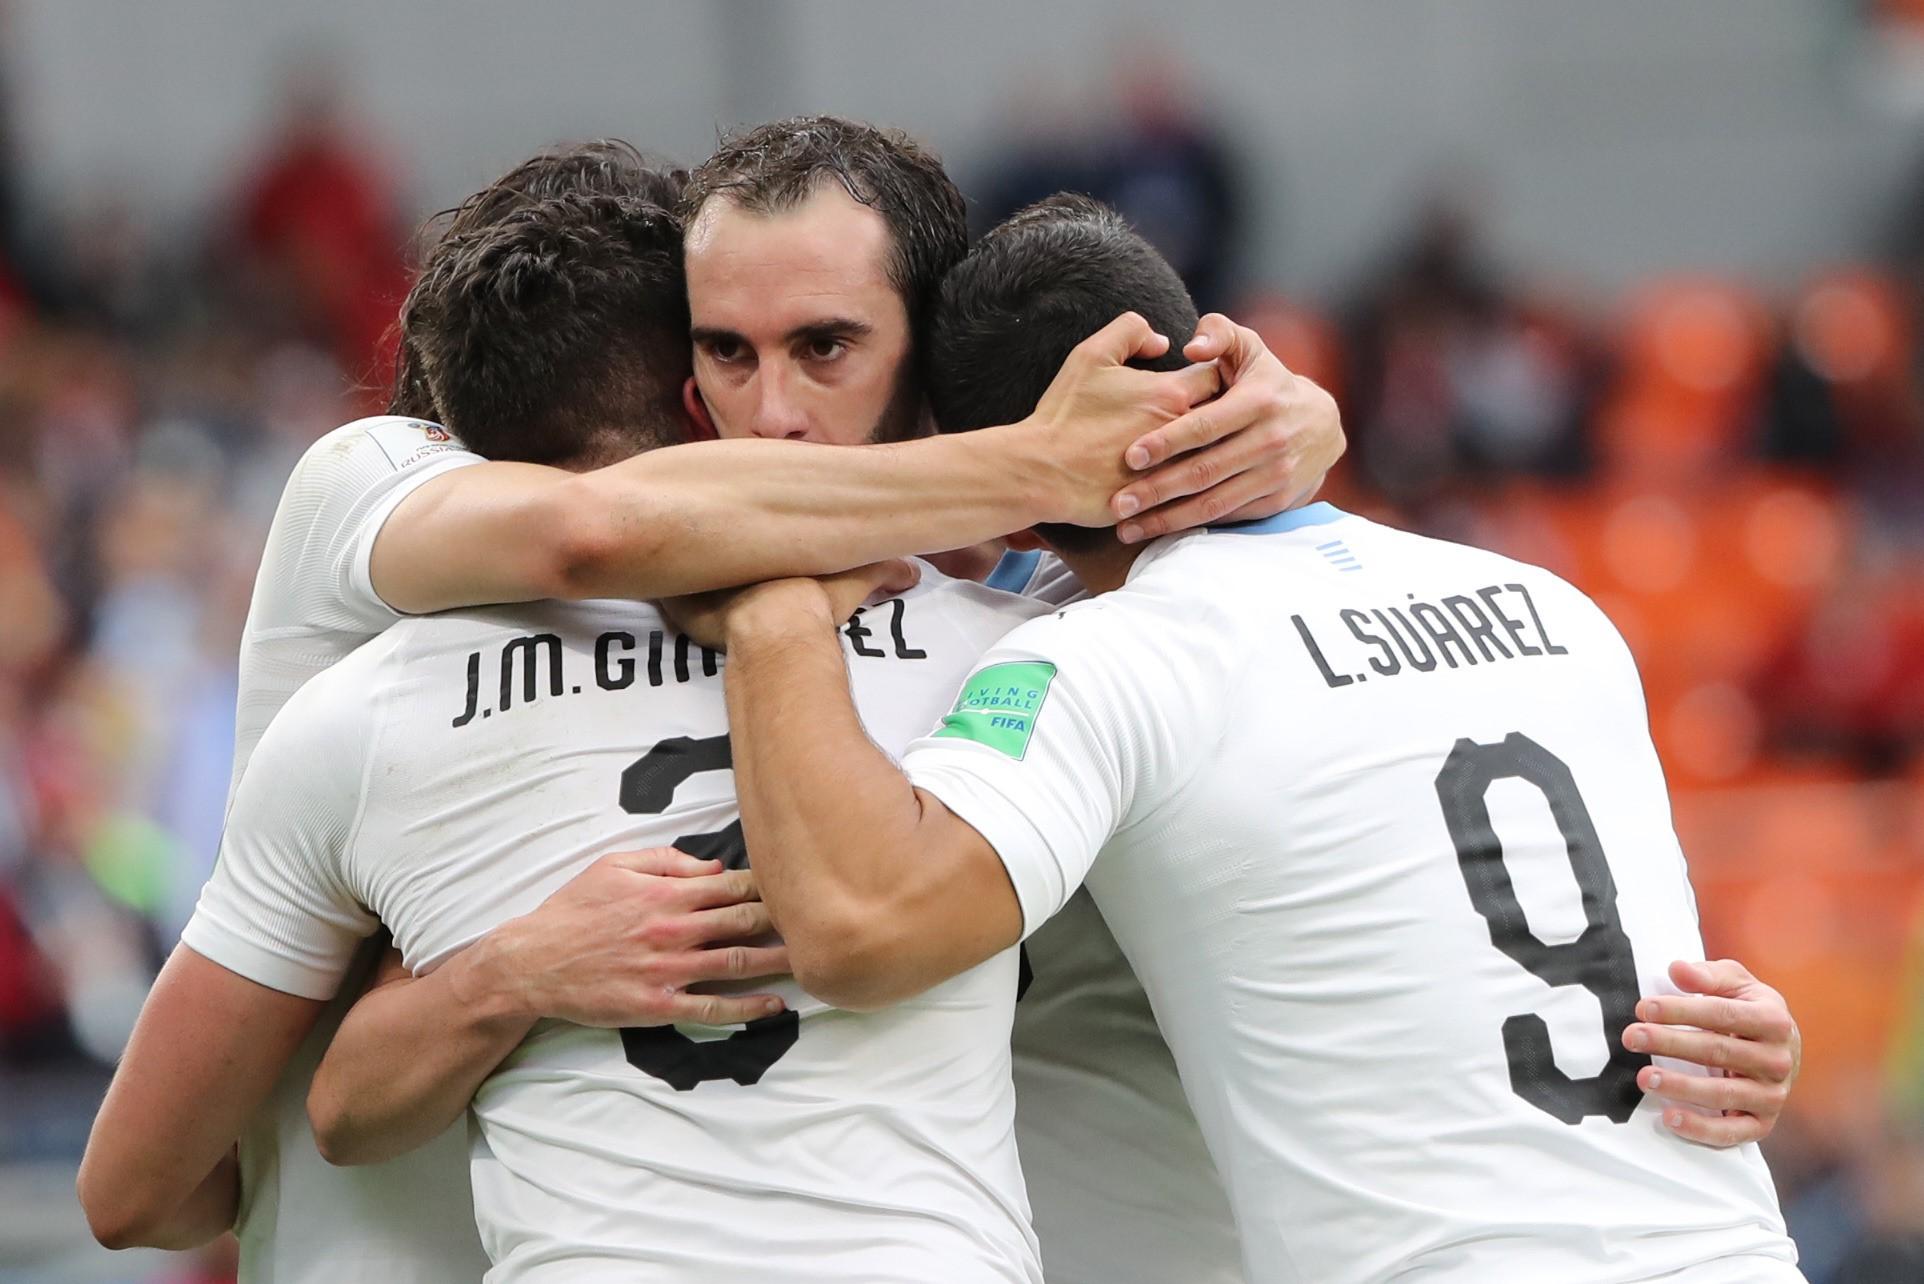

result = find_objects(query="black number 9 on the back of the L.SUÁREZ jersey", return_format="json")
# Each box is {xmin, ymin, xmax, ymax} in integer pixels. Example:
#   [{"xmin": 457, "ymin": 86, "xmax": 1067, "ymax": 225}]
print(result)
[{"xmin": 1437, "ymin": 732, "xmax": 1651, "ymax": 1124}]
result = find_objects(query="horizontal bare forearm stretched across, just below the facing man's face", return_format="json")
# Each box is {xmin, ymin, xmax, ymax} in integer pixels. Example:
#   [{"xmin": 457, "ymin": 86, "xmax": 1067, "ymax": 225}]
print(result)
[{"xmin": 562, "ymin": 425, "xmax": 1072, "ymax": 599}]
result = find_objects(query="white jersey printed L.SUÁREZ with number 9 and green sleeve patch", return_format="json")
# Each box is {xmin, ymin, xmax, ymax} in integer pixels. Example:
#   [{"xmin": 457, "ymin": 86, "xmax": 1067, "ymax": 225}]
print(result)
[{"xmin": 904, "ymin": 504, "xmax": 1801, "ymax": 1284}]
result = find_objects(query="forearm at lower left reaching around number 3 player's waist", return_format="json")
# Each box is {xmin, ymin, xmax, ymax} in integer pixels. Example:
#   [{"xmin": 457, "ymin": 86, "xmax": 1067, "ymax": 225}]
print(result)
[{"xmin": 308, "ymin": 934, "xmax": 535, "ymax": 1165}]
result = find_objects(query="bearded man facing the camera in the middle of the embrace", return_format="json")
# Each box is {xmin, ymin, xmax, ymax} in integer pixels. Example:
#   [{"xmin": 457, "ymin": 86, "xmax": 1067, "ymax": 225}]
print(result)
[{"xmin": 683, "ymin": 117, "xmax": 1795, "ymax": 1284}]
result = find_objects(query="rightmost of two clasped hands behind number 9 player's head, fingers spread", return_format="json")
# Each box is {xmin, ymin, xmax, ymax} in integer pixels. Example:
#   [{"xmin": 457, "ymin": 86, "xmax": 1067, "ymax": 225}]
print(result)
[{"xmin": 1112, "ymin": 312, "xmax": 1347, "ymax": 545}]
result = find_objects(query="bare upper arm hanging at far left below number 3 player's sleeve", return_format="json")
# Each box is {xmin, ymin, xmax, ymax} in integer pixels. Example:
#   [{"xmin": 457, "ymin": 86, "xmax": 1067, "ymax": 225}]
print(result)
[{"xmin": 77, "ymin": 945, "xmax": 321, "ymax": 1249}]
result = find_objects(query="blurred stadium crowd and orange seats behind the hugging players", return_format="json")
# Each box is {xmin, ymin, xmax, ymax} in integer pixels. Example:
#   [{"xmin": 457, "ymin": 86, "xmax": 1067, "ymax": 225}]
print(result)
[{"xmin": 0, "ymin": 0, "xmax": 1924, "ymax": 1284}]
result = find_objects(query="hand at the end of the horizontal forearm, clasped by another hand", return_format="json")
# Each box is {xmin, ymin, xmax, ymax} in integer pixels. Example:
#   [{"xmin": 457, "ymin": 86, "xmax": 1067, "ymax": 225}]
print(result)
[{"xmin": 1020, "ymin": 312, "xmax": 1222, "ymax": 526}]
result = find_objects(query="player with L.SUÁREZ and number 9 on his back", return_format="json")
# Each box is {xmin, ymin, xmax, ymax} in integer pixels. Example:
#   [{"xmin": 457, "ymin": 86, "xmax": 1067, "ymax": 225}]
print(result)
[{"xmin": 689, "ymin": 198, "xmax": 1801, "ymax": 1284}]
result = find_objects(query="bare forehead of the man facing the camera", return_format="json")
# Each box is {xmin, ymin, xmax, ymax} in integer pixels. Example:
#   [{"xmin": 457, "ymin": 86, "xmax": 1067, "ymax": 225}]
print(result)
[{"xmin": 687, "ymin": 181, "xmax": 900, "ymax": 333}]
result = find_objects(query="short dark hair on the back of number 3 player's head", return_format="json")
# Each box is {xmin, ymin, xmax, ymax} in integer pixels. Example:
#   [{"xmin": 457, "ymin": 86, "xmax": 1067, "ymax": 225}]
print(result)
[{"xmin": 402, "ymin": 193, "xmax": 689, "ymax": 466}]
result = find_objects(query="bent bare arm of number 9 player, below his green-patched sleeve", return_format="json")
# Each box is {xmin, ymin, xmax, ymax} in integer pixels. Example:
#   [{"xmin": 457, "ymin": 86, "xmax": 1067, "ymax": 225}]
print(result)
[{"xmin": 725, "ymin": 572, "xmax": 1022, "ymax": 1011}]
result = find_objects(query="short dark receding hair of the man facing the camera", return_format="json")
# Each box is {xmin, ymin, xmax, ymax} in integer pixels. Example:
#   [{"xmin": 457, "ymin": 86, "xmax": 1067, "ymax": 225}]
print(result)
[{"xmin": 681, "ymin": 116, "xmax": 968, "ymax": 352}]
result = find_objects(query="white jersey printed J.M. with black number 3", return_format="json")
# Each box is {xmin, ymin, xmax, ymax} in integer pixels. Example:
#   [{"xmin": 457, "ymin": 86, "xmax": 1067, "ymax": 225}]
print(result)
[{"xmin": 185, "ymin": 570, "xmax": 1041, "ymax": 1284}]
